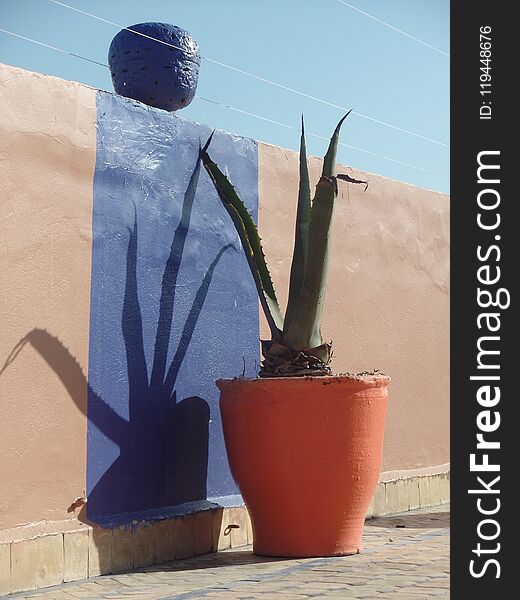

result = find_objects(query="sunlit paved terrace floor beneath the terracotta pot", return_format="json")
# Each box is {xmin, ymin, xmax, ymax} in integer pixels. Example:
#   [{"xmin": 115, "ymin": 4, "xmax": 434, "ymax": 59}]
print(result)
[{"xmin": 9, "ymin": 504, "xmax": 449, "ymax": 600}]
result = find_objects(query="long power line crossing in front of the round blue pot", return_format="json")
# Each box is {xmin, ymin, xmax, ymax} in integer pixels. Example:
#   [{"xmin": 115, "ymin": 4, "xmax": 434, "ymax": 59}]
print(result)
[{"xmin": 48, "ymin": 0, "xmax": 449, "ymax": 148}]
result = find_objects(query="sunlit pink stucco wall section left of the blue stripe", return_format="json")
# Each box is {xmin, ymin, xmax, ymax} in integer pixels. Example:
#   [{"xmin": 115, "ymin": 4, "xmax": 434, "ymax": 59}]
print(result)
[{"xmin": 0, "ymin": 65, "xmax": 96, "ymax": 530}]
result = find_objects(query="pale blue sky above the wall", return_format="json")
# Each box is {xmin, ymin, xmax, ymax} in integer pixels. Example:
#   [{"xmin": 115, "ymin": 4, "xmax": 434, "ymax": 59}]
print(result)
[{"xmin": 0, "ymin": 0, "xmax": 449, "ymax": 192}]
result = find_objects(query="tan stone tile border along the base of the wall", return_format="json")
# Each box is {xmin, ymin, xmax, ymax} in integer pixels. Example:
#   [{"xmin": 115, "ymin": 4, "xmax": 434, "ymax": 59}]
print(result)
[{"xmin": 0, "ymin": 473, "xmax": 449, "ymax": 595}]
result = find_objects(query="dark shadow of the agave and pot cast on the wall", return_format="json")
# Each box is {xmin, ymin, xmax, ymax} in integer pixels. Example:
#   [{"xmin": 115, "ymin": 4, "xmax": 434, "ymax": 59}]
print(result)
[{"xmin": 0, "ymin": 159, "xmax": 233, "ymax": 521}]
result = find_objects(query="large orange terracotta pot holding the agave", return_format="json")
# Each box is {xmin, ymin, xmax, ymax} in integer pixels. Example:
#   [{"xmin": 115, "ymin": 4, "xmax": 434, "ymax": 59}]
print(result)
[{"xmin": 217, "ymin": 376, "xmax": 390, "ymax": 557}]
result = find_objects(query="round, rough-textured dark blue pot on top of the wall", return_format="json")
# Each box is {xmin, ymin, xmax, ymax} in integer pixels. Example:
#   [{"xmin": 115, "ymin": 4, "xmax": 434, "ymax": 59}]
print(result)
[{"xmin": 108, "ymin": 23, "xmax": 200, "ymax": 111}]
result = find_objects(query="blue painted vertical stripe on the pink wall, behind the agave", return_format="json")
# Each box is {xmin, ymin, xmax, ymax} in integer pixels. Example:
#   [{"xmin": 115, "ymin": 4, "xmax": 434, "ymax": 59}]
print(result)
[{"xmin": 87, "ymin": 92, "xmax": 259, "ymax": 520}]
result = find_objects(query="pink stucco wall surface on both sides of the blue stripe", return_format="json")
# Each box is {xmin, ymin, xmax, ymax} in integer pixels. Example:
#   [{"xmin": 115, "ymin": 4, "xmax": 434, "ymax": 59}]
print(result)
[{"xmin": 0, "ymin": 65, "xmax": 449, "ymax": 530}]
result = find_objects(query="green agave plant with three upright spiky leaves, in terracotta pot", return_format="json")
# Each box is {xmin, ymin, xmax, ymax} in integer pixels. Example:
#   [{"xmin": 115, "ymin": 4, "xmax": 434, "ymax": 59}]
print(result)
[{"xmin": 200, "ymin": 111, "xmax": 368, "ymax": 377}]
